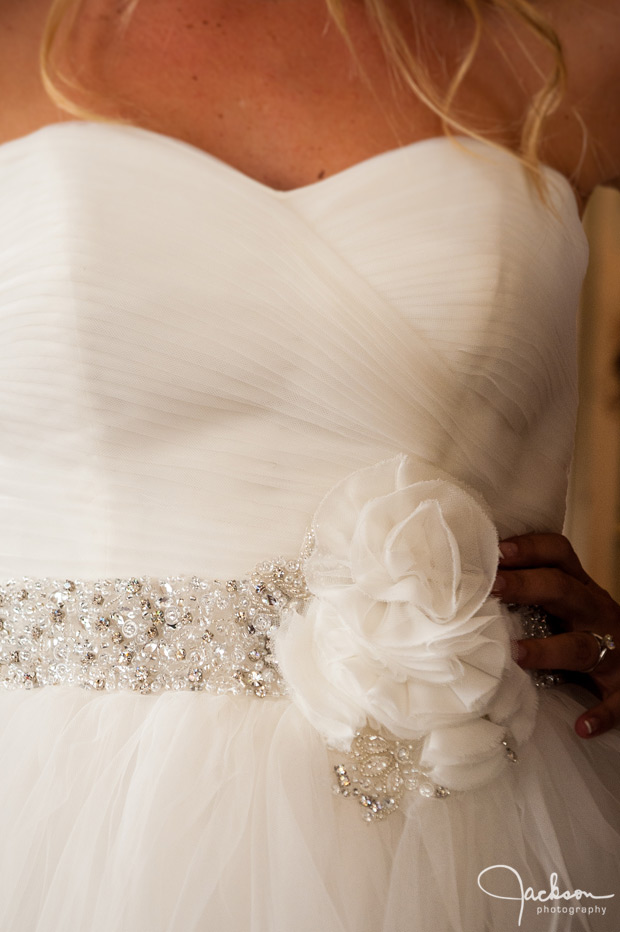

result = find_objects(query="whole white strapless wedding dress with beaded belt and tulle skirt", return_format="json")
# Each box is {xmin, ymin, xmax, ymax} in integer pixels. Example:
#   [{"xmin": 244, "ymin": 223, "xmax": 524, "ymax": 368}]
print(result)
[{"xmin": 0, "ymin": 122, "xmax": 620, "ymax": 932}]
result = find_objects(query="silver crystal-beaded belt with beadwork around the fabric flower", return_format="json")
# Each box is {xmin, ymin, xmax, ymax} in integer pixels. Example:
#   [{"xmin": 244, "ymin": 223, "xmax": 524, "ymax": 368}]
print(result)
[{"xmin": 0, "ymin": 557, "xmax": 549, "ymax": 822}]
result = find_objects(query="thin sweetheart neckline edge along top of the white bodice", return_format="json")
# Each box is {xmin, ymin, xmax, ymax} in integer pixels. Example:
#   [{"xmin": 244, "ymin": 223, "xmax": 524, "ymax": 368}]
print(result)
[{"xmin": 0, "ymin": 120, "xmax": 580, "ymax": 214}]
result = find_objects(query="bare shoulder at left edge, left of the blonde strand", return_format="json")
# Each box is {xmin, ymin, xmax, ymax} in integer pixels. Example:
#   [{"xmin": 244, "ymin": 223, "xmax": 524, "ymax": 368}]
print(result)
[{"xmin": 0, "ymin": 0, "xmax": 62, "ymax": 143}]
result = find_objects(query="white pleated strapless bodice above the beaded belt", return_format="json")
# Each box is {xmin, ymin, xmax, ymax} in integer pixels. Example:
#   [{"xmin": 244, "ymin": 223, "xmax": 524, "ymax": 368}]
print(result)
[{"xmin": 0, "ymin": 122, "xmax": 587, "ymax": 578}]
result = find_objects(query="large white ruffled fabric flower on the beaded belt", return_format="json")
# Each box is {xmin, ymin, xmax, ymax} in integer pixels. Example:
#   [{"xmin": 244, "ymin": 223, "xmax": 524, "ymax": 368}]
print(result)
[{"xmin": 275, "ymin": 455, "xmax": 536, "ymax": 790}]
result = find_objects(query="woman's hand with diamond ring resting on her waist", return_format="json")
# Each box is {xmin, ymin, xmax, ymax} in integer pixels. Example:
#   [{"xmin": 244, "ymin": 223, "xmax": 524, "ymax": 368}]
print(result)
[{"xmin": 493, "ymin": 534, "xmax": 620, "ymax": 738}]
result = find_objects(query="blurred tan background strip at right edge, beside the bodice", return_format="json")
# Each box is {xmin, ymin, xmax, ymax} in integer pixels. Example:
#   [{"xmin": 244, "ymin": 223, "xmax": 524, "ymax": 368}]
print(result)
[{"xmin": 565, "ymin": 188, "xmax": 620, "ymax": 599}]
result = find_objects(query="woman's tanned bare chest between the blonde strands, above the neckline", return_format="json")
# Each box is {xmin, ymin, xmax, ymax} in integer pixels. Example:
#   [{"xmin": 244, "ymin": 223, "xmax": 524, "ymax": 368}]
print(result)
[{"xmin": 70, "ymin": 0, "xmax": 441, "ymax": 190}]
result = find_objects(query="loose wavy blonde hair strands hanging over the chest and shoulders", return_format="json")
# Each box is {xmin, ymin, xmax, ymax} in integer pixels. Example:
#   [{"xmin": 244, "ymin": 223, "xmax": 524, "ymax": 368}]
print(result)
[{"xmin": 40, "ymin": 0, "xmax": 566, "ymax": 187}]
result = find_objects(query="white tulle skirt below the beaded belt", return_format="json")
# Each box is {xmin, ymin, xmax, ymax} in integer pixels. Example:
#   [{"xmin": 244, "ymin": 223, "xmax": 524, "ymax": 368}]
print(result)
[{"xmin": 0, "ymin": 687, "xmax": 620, "ymax": 932}]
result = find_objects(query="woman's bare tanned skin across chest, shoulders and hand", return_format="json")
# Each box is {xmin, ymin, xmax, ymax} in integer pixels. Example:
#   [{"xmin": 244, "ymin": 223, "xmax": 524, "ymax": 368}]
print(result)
[{"xmin": 0, "ymin": 0, "xmax": 620, "ymax": 738}]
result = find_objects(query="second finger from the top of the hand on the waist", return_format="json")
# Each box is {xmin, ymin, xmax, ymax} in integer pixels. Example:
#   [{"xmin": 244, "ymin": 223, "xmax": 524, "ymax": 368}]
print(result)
[{"xmin": 491, "ymin": 567, "xmax": 596, "ymax": 627}]
